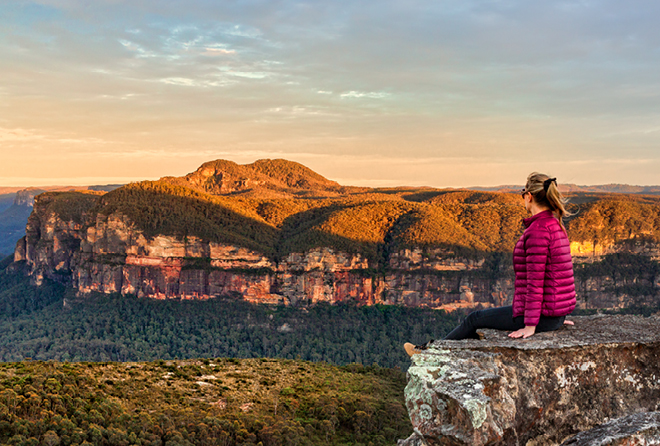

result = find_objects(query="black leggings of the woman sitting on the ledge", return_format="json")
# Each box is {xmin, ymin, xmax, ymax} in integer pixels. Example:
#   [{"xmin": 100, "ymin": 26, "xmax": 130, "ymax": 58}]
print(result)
[{"xmin": 445, "ymin": 305, "xmax": 566, "ymax": 340}]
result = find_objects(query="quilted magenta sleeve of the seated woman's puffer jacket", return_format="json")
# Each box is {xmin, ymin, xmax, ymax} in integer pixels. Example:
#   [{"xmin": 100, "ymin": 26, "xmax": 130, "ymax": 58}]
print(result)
[{"xmin": 525, "ymin": 228, "xmax": 550, "ymax": 326}]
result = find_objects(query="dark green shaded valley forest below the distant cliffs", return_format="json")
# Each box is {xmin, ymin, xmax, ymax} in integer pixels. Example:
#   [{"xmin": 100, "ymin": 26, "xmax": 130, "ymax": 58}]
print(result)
[{"xmin": 0, "ymin": 262, "xmax": 459, "ymax": 370}]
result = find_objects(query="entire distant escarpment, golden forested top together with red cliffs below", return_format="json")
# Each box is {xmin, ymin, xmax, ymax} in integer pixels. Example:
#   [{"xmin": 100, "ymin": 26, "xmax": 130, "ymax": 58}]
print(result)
[{"xmin": 15, "ymin": 160, "xmax": 660, "ymax": 310}]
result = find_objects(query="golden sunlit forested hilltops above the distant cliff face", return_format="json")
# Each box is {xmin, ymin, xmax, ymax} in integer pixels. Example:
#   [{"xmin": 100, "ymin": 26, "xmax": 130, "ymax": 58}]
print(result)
[{"xmin": 25, "ymin": 160, "xmax": 660, "ymax": 261}]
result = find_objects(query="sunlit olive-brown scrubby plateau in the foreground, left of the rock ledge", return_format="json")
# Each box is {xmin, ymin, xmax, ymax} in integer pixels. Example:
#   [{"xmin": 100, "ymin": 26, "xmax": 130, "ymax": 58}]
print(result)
[{"xmin": 0, "ymin": 358, "xmax": 411, "ymax": 446}]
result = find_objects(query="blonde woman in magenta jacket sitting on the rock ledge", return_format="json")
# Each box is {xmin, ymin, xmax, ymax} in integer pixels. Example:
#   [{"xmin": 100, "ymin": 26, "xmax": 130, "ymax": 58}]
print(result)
[{"xmin": 404, "ymin": 172, "xmax": 575, "ymax": 355}]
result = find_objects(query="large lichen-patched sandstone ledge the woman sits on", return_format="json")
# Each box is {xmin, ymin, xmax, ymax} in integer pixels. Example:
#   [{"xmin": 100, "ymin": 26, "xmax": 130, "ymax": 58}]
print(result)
[{"xmin": 399, "ymin": 316, "xmax": 660, "ymax": 446}]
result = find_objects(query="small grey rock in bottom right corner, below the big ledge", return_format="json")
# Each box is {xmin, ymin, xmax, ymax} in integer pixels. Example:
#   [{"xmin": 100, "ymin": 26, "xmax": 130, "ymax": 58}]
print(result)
[{"xmin": 562, "ymin": 412, "xmax": 660, "ymax": 446}]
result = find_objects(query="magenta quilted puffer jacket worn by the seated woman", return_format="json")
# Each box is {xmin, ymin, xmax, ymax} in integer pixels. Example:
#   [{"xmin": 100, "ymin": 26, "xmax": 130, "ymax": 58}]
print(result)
[{"xmin": 513, "ymin": 211, "xmax": 575, "ymax": 326}]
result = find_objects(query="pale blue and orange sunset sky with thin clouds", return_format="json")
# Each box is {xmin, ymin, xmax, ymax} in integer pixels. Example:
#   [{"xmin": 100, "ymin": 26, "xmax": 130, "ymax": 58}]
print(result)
[{"xmin": 0, "ymin": 0, "xmax": 660, "ymax": 187}]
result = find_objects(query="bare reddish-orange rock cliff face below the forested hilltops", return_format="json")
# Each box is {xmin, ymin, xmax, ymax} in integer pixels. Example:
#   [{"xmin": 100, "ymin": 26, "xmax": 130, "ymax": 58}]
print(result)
[{"xmin": 15, "ymin": 194, "xmax": 660, "ymax": 311}]
